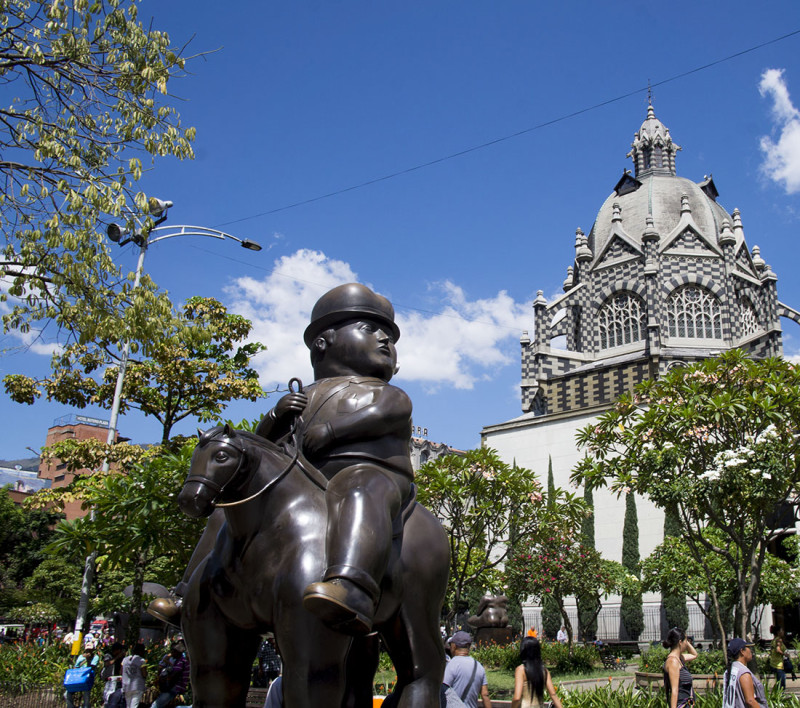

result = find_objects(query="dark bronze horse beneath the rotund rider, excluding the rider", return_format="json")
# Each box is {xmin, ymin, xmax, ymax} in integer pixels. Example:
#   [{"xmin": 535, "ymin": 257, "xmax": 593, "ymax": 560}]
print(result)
[{"xmin": 179, "ymin": 426, "xmax": 449, "ymax": 708}]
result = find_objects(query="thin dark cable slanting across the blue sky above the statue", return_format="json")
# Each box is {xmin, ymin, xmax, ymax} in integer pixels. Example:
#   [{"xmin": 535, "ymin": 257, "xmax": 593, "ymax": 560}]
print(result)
[{"xmin": 216, "ymin": 29, "xmax": 800, "ymax": 228}]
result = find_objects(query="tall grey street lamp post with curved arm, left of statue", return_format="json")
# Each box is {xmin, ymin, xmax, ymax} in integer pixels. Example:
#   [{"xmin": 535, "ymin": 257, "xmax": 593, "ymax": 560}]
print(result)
[{"xmin": 72, "ymin": 197, "xmax": 261, "ymax": 656}]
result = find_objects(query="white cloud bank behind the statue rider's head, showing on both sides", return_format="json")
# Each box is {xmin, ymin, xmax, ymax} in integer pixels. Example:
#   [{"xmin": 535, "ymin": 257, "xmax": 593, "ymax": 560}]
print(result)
[{"xmin": 227, "ymin": 250, "xmax": 532, "ymax": 389}]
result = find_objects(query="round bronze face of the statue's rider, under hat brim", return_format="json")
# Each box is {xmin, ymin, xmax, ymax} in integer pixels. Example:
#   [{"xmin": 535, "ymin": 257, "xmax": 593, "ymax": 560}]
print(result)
[{"xmin": 325, "ymin": 319, "xmax": 397, "ymax": 381}]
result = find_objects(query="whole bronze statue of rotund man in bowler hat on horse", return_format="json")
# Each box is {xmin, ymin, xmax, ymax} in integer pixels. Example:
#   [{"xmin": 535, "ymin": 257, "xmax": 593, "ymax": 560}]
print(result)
[{"xmin": 173, "ymin": 284, "xmax": 449, "ymax": 708}]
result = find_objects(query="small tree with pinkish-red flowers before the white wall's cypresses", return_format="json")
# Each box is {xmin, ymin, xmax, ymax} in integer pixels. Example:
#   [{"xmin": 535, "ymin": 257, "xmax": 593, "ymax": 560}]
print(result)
[{"xmin": 506, "ymin": 523, "xmax": 624, "ymax": 651}]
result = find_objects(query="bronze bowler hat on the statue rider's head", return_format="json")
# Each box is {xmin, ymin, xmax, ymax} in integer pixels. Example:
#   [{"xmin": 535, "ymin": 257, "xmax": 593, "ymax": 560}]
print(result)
[{"xmin": 303, "ymin": 283, "xmax": 400, "ymax": 349}]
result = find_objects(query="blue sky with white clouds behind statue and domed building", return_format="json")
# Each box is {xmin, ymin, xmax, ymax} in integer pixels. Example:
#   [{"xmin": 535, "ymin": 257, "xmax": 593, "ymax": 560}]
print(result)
[{"xmin": 0, "ymin": 0, "xmax": 800, "ymax": 462}]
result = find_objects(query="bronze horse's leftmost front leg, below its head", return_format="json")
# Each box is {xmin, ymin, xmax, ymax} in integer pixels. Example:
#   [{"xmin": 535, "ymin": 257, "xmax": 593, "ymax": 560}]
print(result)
[{"xmin": 182, "ymin": 584, "xmax": 261, "ymax": 708}]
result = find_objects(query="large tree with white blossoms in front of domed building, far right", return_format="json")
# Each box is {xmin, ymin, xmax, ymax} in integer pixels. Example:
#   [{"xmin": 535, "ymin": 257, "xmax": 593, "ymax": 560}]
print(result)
[{"xmin": 573, "ymin": 350, "xmax": 800, "ymax": 636}]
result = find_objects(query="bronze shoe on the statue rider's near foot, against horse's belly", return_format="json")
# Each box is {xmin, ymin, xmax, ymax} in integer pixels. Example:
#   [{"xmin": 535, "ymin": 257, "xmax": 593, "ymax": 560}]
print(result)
[{"xmin": 303, "ymin": 578, "xmax": 375, "ymax": 636}]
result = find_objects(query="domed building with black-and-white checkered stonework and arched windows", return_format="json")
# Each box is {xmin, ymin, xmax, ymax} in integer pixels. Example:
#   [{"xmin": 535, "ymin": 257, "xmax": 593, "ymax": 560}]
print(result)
[{"xmin": 482, "ymin": 104, "xmax": 800, "ymax": 641}]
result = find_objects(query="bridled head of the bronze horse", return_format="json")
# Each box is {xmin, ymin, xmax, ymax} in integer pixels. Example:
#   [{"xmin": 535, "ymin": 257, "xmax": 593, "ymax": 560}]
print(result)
[{"xmin": 178, "ymin": 425, "xmax": 252, "ymax": 518}]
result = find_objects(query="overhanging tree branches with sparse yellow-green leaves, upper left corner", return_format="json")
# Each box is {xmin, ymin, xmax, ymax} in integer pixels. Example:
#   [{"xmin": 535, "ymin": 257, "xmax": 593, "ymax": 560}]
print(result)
[{"xmin": 0, "ymin": 0, "xmax": 194, "ymax": 343}]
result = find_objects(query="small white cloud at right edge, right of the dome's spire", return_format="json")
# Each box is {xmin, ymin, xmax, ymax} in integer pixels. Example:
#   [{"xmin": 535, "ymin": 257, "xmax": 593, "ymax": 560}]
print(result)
[{"xmin": 758, "ymin": 69, "xmax": 800, "ymax": 194}]
